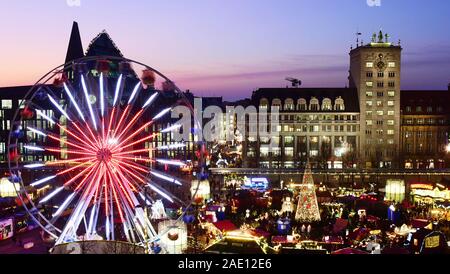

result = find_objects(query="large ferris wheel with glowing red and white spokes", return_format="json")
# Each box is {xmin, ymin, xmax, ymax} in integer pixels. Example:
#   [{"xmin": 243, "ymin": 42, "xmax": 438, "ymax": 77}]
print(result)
[{"xmin": 8, "ymin": 57, "xmax": 198, "ymax": 254}]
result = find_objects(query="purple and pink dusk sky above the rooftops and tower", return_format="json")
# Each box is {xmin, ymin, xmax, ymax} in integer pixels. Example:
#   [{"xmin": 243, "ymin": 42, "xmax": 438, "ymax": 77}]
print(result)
[{"xmin": 0, "ymin": 0, "xmax": 450, "ymax": 99}]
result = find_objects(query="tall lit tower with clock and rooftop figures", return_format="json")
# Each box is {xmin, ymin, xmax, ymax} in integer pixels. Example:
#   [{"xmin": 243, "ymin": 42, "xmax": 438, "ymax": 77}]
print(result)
[{"xmin": 349, "ymin": 31, "xmax": 402, "ymax": 168}]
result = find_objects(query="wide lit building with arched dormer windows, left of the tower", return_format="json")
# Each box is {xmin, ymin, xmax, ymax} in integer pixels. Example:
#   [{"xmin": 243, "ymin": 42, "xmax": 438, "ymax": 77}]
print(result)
[{"xmin": 243, "ymin": 88, "xmax": 360, "ymax": 169}]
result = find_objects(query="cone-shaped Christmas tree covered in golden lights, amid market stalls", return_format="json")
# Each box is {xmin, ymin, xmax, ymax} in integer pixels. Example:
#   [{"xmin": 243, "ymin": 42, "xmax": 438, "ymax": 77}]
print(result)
[{"xmin": 295, "ymin": 163, "xmax": 320, "ymax": 222}]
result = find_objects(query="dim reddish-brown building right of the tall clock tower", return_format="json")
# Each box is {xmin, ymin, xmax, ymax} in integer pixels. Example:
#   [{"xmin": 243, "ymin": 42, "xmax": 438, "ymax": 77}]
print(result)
[{"xmin": 400, "ymin": 87, "xmax": 450, "ymax": 169}]
